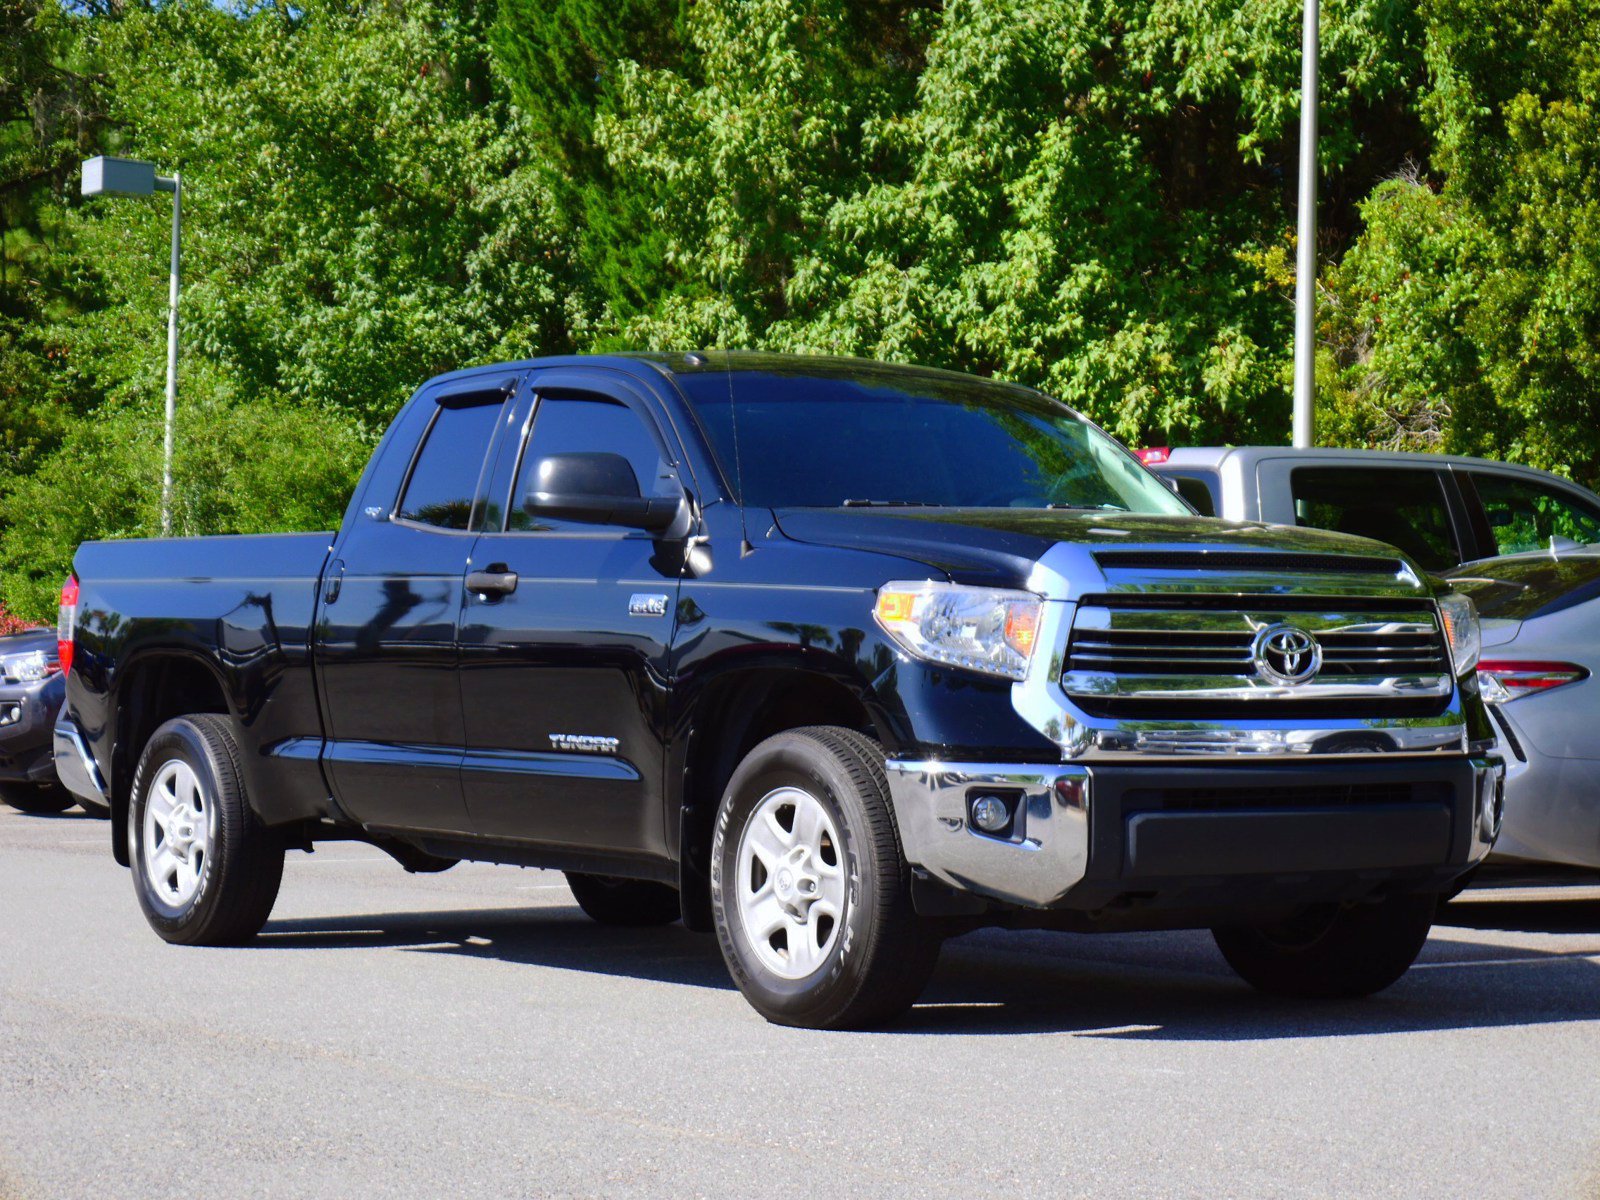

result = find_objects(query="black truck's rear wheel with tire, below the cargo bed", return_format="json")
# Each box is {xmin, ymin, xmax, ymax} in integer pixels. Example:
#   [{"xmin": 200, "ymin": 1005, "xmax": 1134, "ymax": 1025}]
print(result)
[{"xmin": 128, "ymin": 714, "xmax": 283, "ymax": 946}]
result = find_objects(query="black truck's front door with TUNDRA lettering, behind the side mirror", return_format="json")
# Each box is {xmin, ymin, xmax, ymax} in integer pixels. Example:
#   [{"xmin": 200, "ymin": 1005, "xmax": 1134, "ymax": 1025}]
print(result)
[{"xmin": 459, "ymin": 370, "xmax": 682, "ymax": 859}]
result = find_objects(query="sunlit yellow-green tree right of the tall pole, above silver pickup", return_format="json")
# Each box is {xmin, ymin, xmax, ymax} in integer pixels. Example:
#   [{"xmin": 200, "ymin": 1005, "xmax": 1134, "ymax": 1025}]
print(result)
[{"xmin": 1325, "ymin": 0, "xmax": 1600, "ymax": 483}]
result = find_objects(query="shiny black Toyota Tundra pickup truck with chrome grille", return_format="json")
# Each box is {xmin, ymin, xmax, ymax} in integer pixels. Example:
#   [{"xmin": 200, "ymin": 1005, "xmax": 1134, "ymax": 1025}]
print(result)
[{"xmin": 56, "ymin": 354, "xmax": 1502, "ymax": 1027}]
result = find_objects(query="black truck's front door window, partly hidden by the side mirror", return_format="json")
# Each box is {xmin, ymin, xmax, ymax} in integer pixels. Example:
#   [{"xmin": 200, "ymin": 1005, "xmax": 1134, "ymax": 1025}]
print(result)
[{"xmin": 507, "ymin": 395, "xmax": 678, "ymax": 530}]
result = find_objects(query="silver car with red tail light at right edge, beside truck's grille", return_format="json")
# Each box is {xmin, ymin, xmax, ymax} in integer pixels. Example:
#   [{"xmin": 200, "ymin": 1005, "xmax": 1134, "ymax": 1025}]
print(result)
[{"xmin": 1450, "ymin": 547, "xmax": 1600, "ymax": 867}]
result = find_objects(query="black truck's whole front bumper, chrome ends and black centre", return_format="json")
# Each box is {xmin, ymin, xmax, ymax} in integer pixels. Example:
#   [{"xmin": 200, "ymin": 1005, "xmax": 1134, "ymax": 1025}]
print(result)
[{"xmin": 888, "ymin": 755, "xmax": 1504, "ymax": 912}]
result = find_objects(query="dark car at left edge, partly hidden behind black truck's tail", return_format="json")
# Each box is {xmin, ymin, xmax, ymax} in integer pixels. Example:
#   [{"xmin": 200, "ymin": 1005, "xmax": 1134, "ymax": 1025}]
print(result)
[{"xmin": 0, "ymin": 629, "xmax": 93, "ymax": 813}]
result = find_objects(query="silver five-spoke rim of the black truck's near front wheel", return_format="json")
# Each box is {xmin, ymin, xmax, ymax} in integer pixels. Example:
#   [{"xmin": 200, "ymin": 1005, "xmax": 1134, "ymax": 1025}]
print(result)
[{"xmin": 734, "ymin": 787, "xmax": 846, "ymax": 979}]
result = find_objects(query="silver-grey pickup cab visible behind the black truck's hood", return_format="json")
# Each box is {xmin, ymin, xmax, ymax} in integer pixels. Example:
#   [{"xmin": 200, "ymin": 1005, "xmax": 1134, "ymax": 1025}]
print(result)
[{"xmin": 1141, "ymin": 446, "xmax": 1600, "ymax": 571}]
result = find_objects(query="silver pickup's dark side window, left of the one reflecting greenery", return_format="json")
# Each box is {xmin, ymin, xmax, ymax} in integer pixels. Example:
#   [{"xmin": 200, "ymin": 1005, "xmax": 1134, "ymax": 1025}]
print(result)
[{"xmin": 1290, "ymin": 467, "xmax": 1461, "ymax": 571}]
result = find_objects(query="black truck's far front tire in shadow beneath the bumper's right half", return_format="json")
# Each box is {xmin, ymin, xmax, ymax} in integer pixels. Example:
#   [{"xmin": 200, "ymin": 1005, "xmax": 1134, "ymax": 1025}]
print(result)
[{"xmin": 1211, "ymin": 896, "xmax": 1437, "ymax": 1000}]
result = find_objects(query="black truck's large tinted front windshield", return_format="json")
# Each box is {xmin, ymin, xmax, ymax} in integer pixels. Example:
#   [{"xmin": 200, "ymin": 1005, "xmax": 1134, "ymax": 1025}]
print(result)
[{"xmin": 678, "ymin": 363, "xmax": 1189, "ymax": 515}]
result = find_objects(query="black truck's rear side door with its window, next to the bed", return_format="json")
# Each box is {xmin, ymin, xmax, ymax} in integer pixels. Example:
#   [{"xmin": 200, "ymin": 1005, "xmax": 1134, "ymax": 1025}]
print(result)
[{"xmin": 317, "ymin": 376, "xmax": 515, "ymax": 834}]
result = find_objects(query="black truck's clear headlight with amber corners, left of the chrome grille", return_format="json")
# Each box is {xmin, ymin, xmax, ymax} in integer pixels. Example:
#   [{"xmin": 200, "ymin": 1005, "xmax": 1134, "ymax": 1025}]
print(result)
[{"xmin": 874, "ymin": 582, "xmax": 1043, "ymax": 680}]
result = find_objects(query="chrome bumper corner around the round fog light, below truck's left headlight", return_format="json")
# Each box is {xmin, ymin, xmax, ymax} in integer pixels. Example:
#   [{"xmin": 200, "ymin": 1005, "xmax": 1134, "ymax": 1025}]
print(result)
[{"xmin": 885, "ymin": 758, "xmax": 1090, "ymax": 909}]
